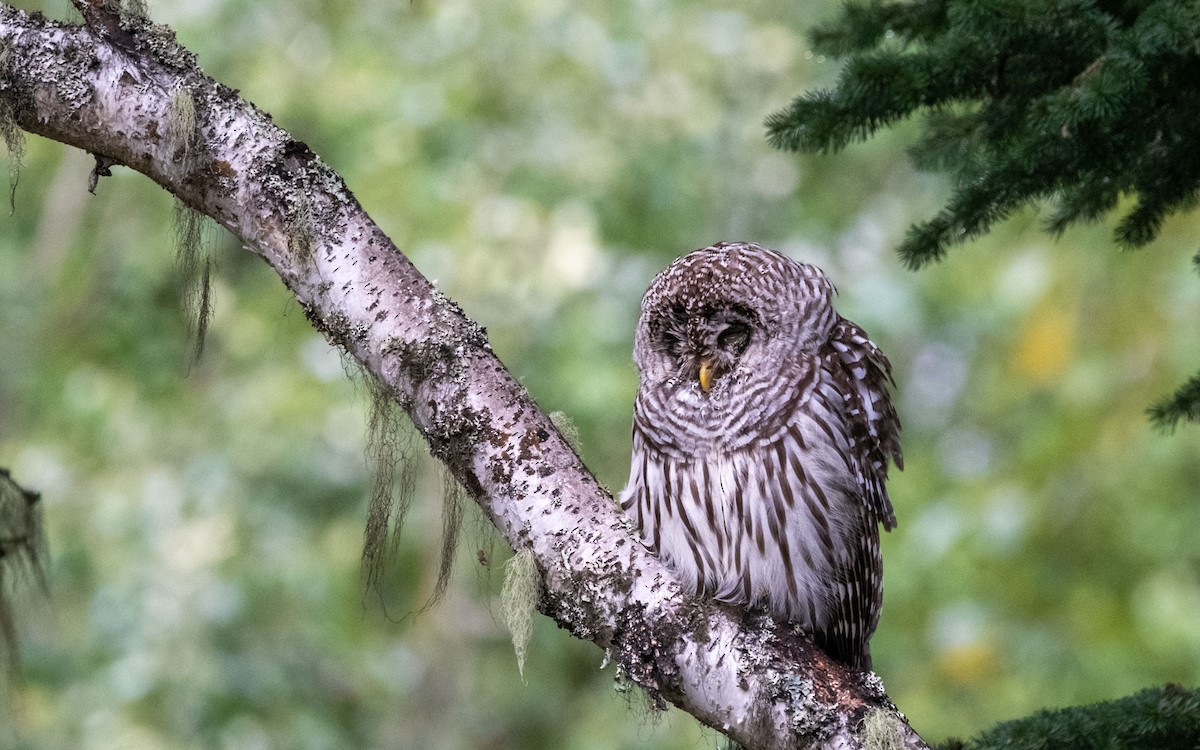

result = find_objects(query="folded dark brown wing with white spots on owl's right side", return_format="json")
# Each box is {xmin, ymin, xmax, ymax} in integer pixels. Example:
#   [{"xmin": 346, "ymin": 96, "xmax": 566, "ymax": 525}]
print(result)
[{"xmin": 828, "ymin": 317, "xmax": 904, "ymax": 532}]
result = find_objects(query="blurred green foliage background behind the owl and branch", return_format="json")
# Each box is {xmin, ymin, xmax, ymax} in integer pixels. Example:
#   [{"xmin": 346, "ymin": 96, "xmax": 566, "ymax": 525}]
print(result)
[{"xmin": 0, "ymin": 0, "xmax": 1200, "ymax": 750}]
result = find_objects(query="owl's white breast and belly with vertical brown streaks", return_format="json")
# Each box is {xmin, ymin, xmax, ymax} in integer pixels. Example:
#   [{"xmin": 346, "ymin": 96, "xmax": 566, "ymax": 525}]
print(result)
[{"xmin": 620, "ymin": 364, "xmax": 865, "ymax": 631}]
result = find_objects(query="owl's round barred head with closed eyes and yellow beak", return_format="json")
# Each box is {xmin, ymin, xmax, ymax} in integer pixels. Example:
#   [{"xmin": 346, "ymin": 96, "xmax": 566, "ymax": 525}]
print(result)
[{"xmin": 634, "ymin": 242, "xmax": 835, "ymax": 452}]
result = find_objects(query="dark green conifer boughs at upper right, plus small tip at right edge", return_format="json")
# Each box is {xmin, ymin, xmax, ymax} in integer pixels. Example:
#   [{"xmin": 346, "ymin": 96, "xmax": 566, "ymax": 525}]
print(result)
[{"xmin": 767, "ymin": 0, "xmax": 1200, "ymax": 428}]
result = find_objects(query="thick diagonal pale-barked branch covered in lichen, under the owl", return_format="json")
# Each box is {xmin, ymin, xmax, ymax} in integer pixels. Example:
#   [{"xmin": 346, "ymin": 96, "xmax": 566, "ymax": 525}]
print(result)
[{"xmin": 0, "ymin": 0, "xmax": 924, "ymax": 749}]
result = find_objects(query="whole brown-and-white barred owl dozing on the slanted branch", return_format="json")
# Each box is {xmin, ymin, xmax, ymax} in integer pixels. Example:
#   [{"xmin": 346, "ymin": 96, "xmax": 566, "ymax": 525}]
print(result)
[{"xmin": 620, "ymin": 242, "xmax": 902, "ymax": 670}]
